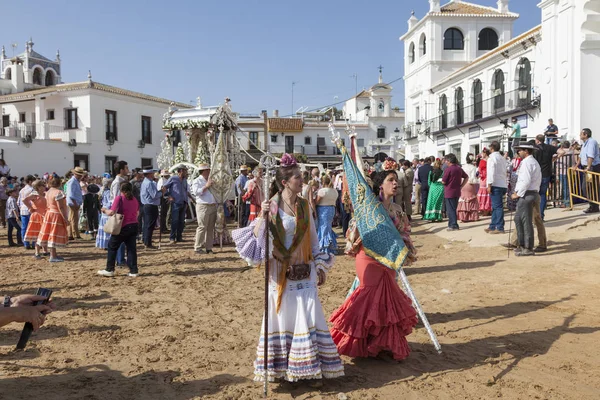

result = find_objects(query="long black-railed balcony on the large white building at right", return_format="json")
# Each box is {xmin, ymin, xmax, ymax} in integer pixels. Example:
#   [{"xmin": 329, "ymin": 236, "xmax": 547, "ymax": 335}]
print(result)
[{"xmin": 412, "ymin": 89, "xmax": 541, "ymax": 140}]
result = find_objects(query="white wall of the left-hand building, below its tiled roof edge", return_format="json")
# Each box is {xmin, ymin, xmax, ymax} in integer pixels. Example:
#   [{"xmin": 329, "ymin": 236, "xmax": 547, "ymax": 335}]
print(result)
[{"xmin": 0, "ymin": 89, "xmax": 180, "ymax": 175}]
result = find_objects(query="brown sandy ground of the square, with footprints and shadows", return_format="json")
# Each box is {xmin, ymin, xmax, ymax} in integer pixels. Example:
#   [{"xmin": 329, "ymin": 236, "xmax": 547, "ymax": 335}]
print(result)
[{"xmin": 0, "ymin": 205, "xmax": 600, "ymax": 400}]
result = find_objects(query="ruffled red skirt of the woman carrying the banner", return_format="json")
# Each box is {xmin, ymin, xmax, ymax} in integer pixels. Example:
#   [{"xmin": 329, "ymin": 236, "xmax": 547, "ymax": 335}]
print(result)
[{"xmin": 329, "ymin": 249, "xmax": 417, "ymax": 360}]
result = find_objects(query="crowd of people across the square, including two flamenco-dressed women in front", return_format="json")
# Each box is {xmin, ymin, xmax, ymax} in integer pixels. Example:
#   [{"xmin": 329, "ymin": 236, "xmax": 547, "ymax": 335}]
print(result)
[{"xmin": 0, "ymin": 129, "xmax": 600, "ymax": 382}]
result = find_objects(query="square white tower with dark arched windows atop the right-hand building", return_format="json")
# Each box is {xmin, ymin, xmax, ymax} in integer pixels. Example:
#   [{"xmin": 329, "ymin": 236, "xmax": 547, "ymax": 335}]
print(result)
[{"xmin": 400, "ymin": 0, "xmax": 519, "ymax": 128}]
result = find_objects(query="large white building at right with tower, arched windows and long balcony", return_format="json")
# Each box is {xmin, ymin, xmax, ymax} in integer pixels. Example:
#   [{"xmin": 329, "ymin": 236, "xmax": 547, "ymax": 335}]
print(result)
[{"xmin": 400, "ymin": 0, "xmax": 600, "ymax": 161}]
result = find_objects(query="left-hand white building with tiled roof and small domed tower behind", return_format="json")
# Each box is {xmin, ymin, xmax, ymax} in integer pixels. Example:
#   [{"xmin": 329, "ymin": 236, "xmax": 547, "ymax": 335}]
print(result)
[{"xmin": 0, "ymin": 40, "xmax": 190, "ymax": 176}]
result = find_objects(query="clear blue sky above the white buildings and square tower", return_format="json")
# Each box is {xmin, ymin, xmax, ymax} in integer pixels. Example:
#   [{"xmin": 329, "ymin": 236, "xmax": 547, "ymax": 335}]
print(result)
[{"xmin": 0, "ymin": 0, "xmax": 540, "ymax": 115}]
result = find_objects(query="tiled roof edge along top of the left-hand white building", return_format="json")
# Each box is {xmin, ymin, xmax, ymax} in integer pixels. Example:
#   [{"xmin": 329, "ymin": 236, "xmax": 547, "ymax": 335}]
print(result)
[{"xmin": 0, "ymin": 81, "xmax": 191, "ymax": 108}]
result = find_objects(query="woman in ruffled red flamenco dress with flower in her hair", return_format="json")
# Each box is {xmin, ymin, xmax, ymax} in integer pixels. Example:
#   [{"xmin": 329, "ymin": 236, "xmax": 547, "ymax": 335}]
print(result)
[{"xmin": 330, "ymin": 170, "xmax": 417, "ymax": 360}]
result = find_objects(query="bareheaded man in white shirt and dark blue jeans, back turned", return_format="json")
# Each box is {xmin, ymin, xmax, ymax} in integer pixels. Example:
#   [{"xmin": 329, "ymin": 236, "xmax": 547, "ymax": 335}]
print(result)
[{"xmin": 485, "ymin": 141, "xmax": 508, "ymax": 233}]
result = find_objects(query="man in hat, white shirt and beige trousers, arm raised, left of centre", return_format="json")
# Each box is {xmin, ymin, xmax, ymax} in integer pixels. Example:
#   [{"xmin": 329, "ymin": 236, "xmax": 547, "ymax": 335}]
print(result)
[{"xmin": 192, "ymin": 164, "xmax": 217, "ymax": 254}]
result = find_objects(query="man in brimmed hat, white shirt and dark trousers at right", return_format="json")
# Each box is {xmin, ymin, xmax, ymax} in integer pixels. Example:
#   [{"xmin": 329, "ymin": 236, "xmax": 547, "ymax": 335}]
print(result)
[{"xmin": 512, "ymin": 144, "xmax": 542, "ymax": 257}]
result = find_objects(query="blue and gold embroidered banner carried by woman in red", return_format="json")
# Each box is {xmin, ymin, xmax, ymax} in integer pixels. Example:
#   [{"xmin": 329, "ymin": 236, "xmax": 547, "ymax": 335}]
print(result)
[{"xmin": 339, "ymin": 144, "xmax": 408, "ymax": 271}]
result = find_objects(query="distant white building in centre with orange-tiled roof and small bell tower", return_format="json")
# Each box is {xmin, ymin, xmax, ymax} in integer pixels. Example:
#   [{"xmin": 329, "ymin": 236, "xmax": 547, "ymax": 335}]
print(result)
[{"xmin": 234, "ymin": 70, "xmax": 404, "ymax": 165}]
